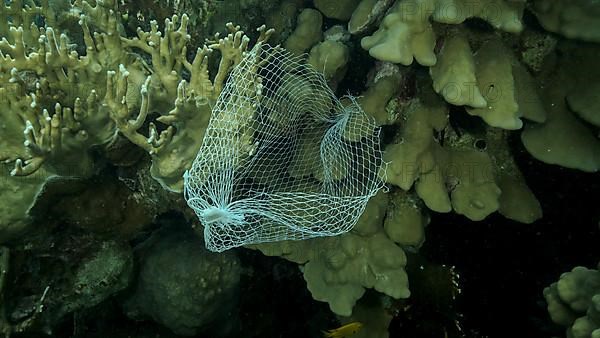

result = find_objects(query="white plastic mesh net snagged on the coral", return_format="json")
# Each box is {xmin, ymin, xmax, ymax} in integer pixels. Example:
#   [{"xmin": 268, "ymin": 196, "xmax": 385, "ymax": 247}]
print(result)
[{"xmin": 184, "ymin": 44, "xmax": 383, "ymax": 252}]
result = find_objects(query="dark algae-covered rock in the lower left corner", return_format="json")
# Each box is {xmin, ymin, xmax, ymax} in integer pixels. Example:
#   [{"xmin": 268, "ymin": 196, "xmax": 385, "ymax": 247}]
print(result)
[{"xmin": 12, "ymin": 238, "xmax": 133, "ymax": 334}]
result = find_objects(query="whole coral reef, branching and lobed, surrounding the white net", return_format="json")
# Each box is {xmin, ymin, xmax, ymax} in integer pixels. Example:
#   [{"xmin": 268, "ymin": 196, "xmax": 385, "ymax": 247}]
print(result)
[{"xmin": 0, "ymin": 0, "xmax": 600, "ymax": 338}]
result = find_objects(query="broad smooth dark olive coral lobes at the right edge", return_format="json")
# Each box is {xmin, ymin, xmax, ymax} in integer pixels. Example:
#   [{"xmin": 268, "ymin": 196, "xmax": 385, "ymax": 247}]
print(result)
[{"xmin": 521, "ymin": 43, "xmax": 600, "ymax": 172}]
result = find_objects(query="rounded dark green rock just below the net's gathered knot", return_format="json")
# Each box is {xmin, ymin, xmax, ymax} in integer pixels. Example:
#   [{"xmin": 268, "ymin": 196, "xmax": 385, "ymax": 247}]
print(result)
[{"xmin": 124, "ymin": 228, "xmax": 240, "ymax": 335}]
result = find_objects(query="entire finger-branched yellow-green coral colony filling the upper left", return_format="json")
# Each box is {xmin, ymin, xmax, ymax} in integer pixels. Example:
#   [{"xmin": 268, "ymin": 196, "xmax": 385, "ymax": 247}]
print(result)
[{"xmin": 0, "ymin": 0, "xmax": 272, "ymax": 240}]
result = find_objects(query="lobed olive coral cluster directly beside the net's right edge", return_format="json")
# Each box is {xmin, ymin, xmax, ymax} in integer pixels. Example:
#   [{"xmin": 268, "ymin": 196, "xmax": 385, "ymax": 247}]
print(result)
[{"xmin": 384, "ymin": 77, "xmax": 524, "ymax": 220}]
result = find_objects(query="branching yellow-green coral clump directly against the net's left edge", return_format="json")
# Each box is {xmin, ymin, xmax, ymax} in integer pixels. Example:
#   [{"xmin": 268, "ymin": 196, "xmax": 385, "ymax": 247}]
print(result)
[{"xmin": 105, "ymin": 15, "xmax": 272, "ymax": 191}]
